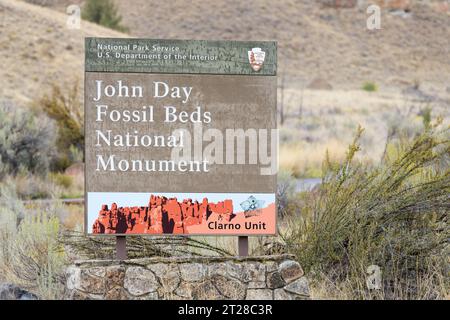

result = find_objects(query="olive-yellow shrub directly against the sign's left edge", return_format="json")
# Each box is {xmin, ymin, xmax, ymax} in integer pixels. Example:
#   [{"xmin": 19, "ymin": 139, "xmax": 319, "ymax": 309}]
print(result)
[{"xmin": 36, "ymin": 85, "xmax": 84, "ymax": 170}]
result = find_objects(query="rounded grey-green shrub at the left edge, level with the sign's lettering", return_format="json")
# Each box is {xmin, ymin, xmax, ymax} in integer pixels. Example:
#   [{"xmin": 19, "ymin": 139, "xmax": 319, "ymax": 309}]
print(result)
[{"xmin": 0, "ymin": 104, "xmax": 56, "ymax": 180}]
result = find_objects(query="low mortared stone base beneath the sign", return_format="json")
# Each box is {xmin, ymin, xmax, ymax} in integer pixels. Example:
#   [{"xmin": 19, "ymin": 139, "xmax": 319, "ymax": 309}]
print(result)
[{"xmin": 65, "ymin": 255, "xmax": 309, "ymax": 300}]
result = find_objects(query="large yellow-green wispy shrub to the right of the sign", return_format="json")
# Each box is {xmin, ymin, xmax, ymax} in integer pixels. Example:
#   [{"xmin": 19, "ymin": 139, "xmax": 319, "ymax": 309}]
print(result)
[{"xmin": 283, "ymin": 126, "xmax": 450, "ymax": 299}]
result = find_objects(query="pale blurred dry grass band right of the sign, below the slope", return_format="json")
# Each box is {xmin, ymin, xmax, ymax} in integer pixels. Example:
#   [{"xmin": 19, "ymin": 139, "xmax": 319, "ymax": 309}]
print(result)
[{"xmin": 279, "ymin": 87, "xmax": 450, "ymax": 178}]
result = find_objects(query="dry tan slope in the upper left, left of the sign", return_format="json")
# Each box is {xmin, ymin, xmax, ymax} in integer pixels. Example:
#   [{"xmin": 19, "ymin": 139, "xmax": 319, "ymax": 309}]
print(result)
[{"xmin": 0, "ymin": 0, "xmax": 124, "ymax": 105}]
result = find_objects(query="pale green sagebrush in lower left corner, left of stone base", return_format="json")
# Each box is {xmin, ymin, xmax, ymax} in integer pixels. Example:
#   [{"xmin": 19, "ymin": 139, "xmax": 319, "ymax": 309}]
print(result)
[{"xmin": 0, "ymin": 186, "xmax": 67, "ymax": 299}]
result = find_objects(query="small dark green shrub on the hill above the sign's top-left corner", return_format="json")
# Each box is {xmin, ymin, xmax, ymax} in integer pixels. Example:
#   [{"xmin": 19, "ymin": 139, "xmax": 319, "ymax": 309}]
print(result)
[{"xmin": 81, "ymin": 0, "xmax": 128, "ymax": 32}]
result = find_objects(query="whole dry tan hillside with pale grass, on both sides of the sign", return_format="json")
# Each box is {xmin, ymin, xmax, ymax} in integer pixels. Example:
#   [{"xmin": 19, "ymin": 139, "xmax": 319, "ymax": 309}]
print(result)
[{"xmin": 0, "ymin": 0, "xmax": 450, "ymax": 177}]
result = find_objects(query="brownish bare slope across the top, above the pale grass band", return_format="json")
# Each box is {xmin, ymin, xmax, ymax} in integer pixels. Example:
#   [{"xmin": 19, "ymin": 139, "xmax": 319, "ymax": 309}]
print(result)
[{"xmin": 116, "ymin": 0, "xmax": 450, "ymax": 92}]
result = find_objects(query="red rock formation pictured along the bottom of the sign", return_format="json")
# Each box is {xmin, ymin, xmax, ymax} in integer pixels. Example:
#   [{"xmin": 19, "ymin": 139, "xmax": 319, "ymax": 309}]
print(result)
[{"xmin": 92, "ymin": 195, "xmax": 233, "ymax": 234}]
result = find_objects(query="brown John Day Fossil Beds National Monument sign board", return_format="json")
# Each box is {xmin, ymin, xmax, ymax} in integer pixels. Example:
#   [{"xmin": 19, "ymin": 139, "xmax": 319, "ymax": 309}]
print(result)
[{"xmin": 85, "ymin": 38, "xmax": 278, "ymax": 236}]
